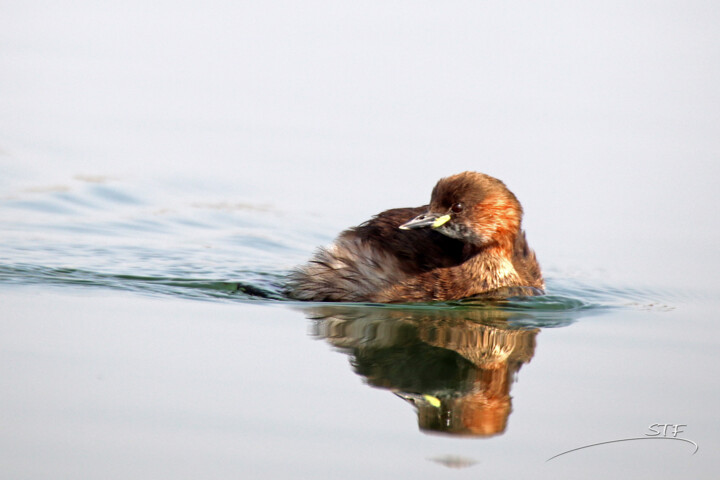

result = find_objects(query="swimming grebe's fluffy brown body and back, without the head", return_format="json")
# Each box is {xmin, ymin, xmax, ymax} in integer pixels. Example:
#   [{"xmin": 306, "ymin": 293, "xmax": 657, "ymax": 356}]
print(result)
[{"xmin": 289, "ymin": 206, "xmax": 543, "ymax": 303}]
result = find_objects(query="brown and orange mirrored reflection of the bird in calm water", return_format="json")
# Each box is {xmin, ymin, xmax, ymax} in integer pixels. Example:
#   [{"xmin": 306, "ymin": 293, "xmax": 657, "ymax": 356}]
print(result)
[{"xmin": 304, "ymin": 305, "xmax": 539, "ymax": 436}]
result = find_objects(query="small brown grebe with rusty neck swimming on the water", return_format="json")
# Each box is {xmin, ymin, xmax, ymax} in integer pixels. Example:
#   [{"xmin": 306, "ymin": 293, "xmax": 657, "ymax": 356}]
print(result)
[{"xmin": 288, "ymin": 172, "xmax": 545, "ymax": 303}]
